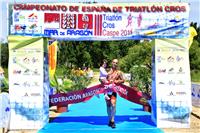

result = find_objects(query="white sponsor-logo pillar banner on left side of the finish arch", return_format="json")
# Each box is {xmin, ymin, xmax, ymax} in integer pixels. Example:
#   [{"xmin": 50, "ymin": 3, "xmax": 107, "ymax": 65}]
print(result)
[{"xmin": 8, "ymin": 36, "xmax": 48, "ymax": 129}]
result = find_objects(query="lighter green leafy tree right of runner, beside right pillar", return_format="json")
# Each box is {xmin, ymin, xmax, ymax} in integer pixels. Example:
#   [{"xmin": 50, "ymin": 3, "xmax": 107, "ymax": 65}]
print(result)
[{"xmin": 120, "ymin": 41, "xmax": 153, "ymax": 94}]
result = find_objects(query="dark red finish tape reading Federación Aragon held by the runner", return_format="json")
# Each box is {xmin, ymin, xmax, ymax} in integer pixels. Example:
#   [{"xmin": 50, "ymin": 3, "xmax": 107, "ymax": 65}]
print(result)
[{"xmin": 50, "ymin": 84, "xmax": 142, "ymax": 106}]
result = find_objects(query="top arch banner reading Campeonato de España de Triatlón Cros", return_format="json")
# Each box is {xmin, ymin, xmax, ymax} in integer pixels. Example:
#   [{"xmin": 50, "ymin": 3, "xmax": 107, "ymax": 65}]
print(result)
[{"xmin": 10, "ymin": 3, "xmax": 189, "ymax": 40}]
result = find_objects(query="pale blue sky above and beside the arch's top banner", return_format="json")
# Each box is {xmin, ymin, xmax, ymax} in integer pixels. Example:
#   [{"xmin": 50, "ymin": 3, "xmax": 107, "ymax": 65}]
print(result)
[{"xmin": 0, "ymin": 0, "xmax": 200, "ymax": 41}]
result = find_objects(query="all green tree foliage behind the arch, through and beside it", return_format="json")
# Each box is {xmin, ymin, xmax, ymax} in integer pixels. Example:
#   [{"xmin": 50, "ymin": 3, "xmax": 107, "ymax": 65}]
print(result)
[{"xmin": 0, "ymin": 23, "xmax": 200, "ymax": 92}]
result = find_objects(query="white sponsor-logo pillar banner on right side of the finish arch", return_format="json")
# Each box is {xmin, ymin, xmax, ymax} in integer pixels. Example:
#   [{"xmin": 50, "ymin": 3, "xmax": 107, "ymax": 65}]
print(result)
[{"xmin": 152, "ymin": 39, "xmax": 191, "ymax": 128}]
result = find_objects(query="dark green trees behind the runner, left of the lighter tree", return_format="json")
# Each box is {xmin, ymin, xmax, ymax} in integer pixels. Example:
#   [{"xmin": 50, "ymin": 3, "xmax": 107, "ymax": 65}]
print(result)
[{"xmin": 58, "ymin": 41, "xmax": 135, "ymax": 68}]
